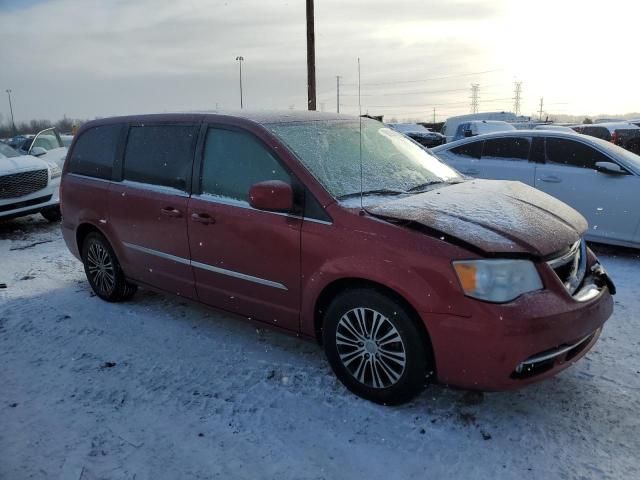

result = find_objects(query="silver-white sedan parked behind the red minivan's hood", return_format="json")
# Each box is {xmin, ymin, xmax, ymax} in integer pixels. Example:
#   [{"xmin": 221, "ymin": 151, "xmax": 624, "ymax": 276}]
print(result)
[{"xmin": 431, "ymin": 130, "xmax": 640, "ymax": 248}]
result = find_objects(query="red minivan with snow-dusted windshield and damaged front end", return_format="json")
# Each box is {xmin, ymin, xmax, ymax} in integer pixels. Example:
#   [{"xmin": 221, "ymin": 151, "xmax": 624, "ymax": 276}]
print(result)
[{"xmin": 61, "ymin": 112, "xmax": 615, "ymax": 404}]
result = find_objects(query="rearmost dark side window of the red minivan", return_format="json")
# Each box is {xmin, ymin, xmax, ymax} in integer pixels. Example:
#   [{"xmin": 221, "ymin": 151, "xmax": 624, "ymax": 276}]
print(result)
[{"xmin": 69, "ymin": 125, "xmax": 122, "ymax": 180}]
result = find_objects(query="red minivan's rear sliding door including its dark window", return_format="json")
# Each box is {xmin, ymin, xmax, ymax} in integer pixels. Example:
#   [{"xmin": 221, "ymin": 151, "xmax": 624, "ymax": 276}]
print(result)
[{"xmin": 108, "ymin": 124, "xmax": 200, "ymax": 298}]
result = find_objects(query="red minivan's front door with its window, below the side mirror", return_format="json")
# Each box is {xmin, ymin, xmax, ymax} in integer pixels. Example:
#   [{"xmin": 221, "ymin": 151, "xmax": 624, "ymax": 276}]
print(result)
[{"xmin": 188, "ymin": 127, "xmax": 302, "ymax": 331}]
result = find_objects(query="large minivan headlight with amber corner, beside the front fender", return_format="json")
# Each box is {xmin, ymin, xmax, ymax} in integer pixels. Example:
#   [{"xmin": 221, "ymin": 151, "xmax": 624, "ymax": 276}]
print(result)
[{"xmin": 453, "ymin": 260, "xmax": 542, "ymax": 303}]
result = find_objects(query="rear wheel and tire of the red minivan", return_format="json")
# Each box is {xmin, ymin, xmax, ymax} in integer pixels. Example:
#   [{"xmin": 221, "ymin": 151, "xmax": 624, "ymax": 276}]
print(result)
[{"xmin": 82, "ymin": 232, "xmax": 138, "ymax": 302}]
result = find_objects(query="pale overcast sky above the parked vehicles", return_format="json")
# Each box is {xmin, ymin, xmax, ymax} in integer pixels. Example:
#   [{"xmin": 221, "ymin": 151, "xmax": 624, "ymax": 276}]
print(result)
[{"xmin": 0, "ymin": 0, "xmax": 640, "ymax": 121}]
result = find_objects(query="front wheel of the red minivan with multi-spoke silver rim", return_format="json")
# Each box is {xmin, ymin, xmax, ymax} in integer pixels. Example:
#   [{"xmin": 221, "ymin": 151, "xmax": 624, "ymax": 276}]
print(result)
[{"xmin": 322, "ymin": 288, "xmax": 434, "ymax": 405}]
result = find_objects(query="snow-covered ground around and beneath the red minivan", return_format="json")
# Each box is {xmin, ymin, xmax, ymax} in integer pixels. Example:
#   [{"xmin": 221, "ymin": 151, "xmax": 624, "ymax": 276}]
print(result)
[{"xmin": 0, "ymin": 216, "xmax": 640, "ymax": 480}]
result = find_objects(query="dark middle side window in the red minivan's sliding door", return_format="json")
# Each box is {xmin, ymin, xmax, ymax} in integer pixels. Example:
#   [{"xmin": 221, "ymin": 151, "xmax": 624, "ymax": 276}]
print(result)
[{"xmin": 123, "ymin": 125, "xmax": 199, "ymax": 191}]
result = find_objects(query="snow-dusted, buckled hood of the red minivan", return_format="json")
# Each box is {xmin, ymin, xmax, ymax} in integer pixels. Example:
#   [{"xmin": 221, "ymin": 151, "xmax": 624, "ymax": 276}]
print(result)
[{"xmin": 367, "ymin": 180, "xmax": 587, "ymax": 257}]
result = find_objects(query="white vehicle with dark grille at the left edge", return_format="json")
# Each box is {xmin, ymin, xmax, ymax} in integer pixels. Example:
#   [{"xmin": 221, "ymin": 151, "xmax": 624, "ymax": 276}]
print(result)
[{"xmin": 0, "ymin": 143, "xmax": 62, "ymax": 222}]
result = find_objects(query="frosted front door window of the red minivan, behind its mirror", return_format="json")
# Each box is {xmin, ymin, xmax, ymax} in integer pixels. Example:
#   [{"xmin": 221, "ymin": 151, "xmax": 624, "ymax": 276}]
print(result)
[{"xmin": 201, "ymin": 128, "xmax": 291, "ymax": 202}]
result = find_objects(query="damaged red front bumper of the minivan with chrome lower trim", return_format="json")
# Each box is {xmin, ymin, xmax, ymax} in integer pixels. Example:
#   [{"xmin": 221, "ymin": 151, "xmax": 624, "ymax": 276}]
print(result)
[{"xmin": 424, "ymin": 264, "xmax": 615, "ymax": 391}]
